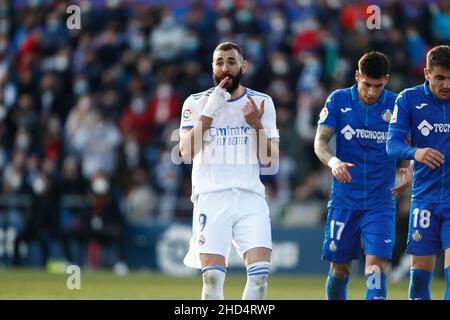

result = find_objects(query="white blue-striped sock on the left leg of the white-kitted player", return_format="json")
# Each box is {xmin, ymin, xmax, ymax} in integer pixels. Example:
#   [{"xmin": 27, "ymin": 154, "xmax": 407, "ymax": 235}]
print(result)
[{"xmin": 202, "ymin": 266, "xmax": 226, "ymax": 300}]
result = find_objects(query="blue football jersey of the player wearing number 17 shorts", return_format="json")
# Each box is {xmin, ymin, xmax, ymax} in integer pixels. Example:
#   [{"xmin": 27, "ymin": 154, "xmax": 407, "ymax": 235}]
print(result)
[{"xmin": 318, "ymin": 84, "xmax": 397, "ymax": 209}]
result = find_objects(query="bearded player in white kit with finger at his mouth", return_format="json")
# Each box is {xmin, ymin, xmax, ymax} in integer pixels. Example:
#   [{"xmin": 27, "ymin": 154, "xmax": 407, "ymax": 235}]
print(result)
[{"xmin": 180, "ymin": 42, "xmax": 279, "ymax": 300}]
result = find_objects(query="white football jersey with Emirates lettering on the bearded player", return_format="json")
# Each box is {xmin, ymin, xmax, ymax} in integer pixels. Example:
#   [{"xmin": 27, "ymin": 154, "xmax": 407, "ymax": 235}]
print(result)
[{"xmin": 180, "ymin": 88, "xmax": 279, "ymax": 200}]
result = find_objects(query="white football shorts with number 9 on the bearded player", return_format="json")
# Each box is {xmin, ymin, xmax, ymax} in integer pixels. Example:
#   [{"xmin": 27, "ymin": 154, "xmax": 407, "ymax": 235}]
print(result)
[{"xmin": 183, "ymin": 188, "xmax": 272, "ymax": 269}]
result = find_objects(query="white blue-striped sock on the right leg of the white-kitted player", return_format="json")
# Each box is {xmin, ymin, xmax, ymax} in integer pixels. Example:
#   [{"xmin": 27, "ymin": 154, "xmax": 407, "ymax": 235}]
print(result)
[{"xmin": 242, "ymin": 261, "xmax": 270, "ymax": 300}]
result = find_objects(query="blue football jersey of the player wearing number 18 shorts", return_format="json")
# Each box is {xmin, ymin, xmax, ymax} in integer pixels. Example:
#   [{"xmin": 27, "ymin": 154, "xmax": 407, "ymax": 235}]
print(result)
[{"xmin": 389, "ymin": 81, "xmax": 450, "ymax": 203}]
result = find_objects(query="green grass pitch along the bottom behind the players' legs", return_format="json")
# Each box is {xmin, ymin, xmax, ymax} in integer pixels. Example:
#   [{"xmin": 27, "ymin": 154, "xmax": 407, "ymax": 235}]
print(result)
[{"xmin": 0, "ymin": 269, "xmax": 445, "ymax": 300}]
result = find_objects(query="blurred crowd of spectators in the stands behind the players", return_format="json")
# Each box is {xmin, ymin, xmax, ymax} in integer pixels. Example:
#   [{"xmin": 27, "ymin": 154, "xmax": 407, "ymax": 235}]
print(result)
[{"xmin": 0, "ymin": 0, "xmax": 450, "ymax": 265}]
